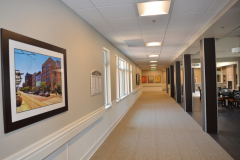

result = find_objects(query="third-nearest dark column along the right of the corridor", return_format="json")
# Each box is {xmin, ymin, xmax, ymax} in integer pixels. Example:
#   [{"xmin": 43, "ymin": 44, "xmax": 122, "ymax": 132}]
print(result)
[{"xmin": 175, "ymin": 61, "xmax": 182, "ymax": 103}]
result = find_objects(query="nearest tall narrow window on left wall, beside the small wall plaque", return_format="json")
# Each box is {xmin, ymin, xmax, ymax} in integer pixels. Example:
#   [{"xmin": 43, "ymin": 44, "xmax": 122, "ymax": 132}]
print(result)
[{"xmin": 103, "ymin": 48, "xmax": 112, "ymax": 106}]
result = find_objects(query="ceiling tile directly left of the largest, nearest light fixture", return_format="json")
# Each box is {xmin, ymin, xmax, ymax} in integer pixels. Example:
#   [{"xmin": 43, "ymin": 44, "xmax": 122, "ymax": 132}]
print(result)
[{"xmin": 98, "ymin": 4, "xmax": 137, "ymax": 19}]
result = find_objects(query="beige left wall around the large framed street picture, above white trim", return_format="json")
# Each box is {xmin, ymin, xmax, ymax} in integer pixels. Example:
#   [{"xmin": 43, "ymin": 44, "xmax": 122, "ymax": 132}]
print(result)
[{"xmin": 0, "ymin": 0, "xmax": 141, "ymax": 159}]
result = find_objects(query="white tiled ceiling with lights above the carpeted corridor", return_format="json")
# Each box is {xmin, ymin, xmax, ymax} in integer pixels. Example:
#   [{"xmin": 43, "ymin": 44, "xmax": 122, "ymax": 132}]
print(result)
[{"xmin": 62, "ymin": 0, "xmax": 236, "ymax": 70}]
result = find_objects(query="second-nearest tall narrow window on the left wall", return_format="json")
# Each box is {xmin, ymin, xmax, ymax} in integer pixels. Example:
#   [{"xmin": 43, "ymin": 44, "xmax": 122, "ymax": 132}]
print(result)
[{"xmin": 119, "ymin": 58, "xmax": 126, "ymax": 97}]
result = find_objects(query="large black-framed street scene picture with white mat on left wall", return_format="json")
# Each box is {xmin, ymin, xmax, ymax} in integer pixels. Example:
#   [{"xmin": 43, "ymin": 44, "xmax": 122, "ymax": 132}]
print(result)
[{"xmin": 1, "ymin": 29, "xmax": 68, "ymax": 133}]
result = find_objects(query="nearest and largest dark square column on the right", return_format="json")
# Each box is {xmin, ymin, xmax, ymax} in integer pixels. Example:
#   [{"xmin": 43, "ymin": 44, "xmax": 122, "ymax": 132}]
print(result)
[{"xmin": 200, "ymin": 38, "xmax": 218, "ymax": 133}]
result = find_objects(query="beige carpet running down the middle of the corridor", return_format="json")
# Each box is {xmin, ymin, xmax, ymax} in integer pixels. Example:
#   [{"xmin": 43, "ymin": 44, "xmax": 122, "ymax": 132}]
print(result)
[{"xmin": 91, "ymin": 92, "xmax": 232, "ymax": 160}]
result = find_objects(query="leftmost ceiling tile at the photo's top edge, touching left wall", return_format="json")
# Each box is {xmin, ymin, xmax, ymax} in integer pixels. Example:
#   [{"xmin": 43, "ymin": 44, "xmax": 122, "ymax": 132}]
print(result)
[{"xmin": 62, "ymin": 0, "xmax": 94, "ymax": 9}]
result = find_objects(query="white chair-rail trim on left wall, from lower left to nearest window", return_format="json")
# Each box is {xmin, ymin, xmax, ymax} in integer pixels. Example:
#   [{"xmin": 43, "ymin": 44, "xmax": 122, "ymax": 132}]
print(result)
[{"xmin": 6, "ymin": 107, "xmax": 106, "ymax": 160}]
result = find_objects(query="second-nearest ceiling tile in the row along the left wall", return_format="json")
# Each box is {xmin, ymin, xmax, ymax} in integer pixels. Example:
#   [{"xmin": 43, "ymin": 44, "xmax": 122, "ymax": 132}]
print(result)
[{"xmin": 74, "ymin": 8, "xmax": 105, "ymax": 21}]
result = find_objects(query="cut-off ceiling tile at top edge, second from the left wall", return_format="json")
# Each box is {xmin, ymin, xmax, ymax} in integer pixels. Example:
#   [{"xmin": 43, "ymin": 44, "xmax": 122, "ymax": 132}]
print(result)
[{"xmin": 91, "ymin": 0, "xmax": 132, "ymax": 7}]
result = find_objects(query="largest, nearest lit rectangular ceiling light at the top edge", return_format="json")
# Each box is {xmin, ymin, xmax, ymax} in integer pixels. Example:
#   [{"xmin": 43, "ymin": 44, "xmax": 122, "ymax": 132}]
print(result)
[{"xmin": 137, "ymin": 1, "xmax": 171, "ymax": 16}]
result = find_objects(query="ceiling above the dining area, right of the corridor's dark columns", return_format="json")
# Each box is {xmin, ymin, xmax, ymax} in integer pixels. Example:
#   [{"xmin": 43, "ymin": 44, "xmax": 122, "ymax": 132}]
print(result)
[{"xmin": 173, "ymin": 1, "xmax": 240, "ymax": 65}]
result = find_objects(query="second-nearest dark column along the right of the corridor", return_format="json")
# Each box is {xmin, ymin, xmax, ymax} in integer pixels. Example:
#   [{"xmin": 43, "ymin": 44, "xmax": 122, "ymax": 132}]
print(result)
[{"xmin": 183, "ymin": 54, "xmax": 193, "ymax": 112}]
